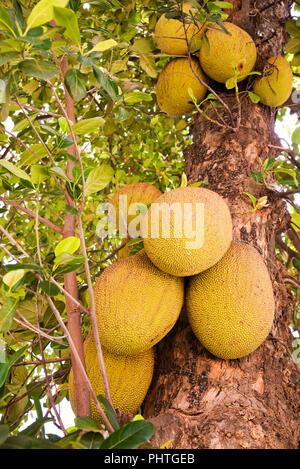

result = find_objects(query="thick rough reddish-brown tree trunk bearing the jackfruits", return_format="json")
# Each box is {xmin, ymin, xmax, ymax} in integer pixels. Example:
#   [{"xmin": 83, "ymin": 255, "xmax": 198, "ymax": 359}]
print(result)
[{"xmin": 144, "ymin": 0, "xmax": 299, "ymax": 449}]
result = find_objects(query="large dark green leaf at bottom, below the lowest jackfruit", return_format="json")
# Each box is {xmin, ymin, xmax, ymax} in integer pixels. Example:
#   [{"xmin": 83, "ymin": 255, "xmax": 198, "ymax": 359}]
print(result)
[{"xmin": 100, "ymin": 420, "xmax": 154, "ymax": 449}]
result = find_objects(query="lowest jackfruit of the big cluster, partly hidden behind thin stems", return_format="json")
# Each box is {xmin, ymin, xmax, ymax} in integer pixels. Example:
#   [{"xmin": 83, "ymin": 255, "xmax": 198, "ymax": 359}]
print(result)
[{"xmin": 69, "ymin": 334, "xmax": 154, "ymax": 422}]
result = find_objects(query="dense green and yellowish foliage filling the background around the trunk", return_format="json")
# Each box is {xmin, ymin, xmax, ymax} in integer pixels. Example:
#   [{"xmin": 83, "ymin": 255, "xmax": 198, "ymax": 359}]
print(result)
[{"xmin": 0, "ymin": 0, "xmax": 300, "ymax": 448}]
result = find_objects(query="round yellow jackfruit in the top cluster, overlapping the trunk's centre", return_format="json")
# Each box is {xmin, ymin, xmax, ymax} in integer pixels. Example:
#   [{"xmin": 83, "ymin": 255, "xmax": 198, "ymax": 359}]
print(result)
[{"xmin": 199, "ymin": 22, "xmax": 257, "ymax": 83}]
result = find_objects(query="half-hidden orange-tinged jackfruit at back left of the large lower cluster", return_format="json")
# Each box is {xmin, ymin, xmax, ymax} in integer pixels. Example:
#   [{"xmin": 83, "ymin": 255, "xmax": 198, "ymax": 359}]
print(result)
[{"xmin": 111, "ymin": 182, "xmax": 162, "ymax": 241}]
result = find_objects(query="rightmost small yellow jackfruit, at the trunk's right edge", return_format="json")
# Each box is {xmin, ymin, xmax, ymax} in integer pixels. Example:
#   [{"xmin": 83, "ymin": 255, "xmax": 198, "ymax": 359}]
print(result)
[{"xmin": 253, "ymin": 56, "xmax": 293, "ymax": 107}]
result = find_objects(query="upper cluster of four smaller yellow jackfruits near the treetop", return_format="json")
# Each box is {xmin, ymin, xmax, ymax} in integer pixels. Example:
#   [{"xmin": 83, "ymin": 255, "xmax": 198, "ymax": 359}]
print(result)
[{"xmin": 154, "ymin": 3, "xmax": 293, "ymax": 117}]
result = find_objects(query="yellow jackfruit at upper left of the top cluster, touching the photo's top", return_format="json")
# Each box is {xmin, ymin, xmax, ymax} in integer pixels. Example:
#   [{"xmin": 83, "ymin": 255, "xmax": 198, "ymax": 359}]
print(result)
[{"xmin": 154, "ymin": 3, "xmax": 204, "ymax": 55}]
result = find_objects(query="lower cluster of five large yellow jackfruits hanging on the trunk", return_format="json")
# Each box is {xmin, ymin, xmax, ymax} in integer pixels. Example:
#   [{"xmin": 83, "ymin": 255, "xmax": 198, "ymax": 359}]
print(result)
[{"xmin": 70, "ymin": 184, "xmax": 274, "ymax": 421}]
